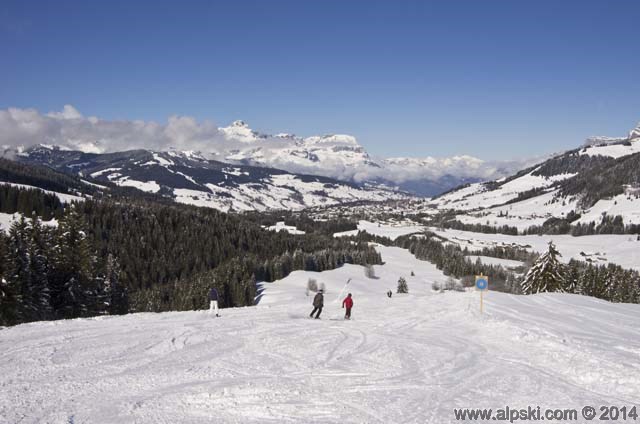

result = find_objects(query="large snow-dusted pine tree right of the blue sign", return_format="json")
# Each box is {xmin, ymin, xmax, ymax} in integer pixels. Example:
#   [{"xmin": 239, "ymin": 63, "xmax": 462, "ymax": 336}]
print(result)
[{"xmin": 522, "ymin": 242, "xmax": 565, "ymax": 294}]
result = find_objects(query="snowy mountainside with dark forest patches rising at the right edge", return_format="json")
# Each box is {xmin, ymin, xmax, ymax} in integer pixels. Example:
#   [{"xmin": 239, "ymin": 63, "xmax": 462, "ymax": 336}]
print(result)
[{"xmin": 432, "ymin": 122, "xmax": 640, "ymax": 230}]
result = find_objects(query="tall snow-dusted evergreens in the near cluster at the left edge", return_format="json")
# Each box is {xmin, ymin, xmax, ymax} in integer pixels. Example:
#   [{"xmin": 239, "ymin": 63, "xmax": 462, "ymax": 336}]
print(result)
[{"xmin": 0, "ymin": 208, "xmax": 128, "ymax": 325}]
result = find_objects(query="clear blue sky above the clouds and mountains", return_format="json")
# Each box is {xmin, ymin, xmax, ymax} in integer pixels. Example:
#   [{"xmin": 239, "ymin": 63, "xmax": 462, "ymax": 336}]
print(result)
[{"xmin": 0, "ymin": 0, "xmax": 640, "ymax": 159}]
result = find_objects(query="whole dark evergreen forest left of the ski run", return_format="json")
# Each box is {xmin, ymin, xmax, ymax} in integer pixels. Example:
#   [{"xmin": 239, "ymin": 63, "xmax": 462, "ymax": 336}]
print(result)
[{"xmin": 0, "ymin": 199, "xmax": 380, "ymax": 325}]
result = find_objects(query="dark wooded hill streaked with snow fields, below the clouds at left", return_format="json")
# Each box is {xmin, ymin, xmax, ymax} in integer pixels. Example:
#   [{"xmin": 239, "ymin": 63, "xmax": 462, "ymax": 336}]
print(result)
[{"xmin": 17, "ymin": 145, "xmax": 406, "ymax": 211}]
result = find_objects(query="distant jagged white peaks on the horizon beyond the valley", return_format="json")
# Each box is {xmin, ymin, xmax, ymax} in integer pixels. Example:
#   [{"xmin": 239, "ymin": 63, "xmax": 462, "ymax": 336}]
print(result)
[{"xmin": 211, "ymin": 121, "xmax": 522, "ymax": 196}]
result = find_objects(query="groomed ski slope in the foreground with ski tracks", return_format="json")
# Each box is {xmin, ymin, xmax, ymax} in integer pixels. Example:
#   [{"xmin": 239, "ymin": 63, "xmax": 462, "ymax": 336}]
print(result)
[{"xmin": 0, "ymin": 247, "xmax": 640, "ymax": 423}]
